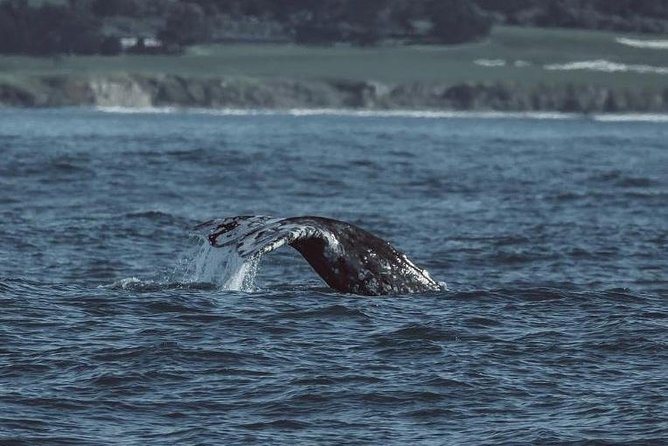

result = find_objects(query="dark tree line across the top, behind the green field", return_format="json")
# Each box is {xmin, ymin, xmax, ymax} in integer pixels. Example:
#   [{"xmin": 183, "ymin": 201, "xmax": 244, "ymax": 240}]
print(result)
[{"xmin": 0, "ymin": 0, "xmax": 668, "ymax": 55}]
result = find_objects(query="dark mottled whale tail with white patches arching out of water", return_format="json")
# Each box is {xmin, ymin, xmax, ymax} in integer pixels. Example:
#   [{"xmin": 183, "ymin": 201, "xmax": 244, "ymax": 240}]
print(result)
[{"xmin": 194, "ymin": 215, "xmax": 445, "ymax": 296}]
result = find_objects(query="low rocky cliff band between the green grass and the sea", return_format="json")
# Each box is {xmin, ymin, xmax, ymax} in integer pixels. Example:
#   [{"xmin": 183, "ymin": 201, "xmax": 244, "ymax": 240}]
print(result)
[{"xmin": 0, "ymin": 75, "xmax": 668, "ymax": 113}]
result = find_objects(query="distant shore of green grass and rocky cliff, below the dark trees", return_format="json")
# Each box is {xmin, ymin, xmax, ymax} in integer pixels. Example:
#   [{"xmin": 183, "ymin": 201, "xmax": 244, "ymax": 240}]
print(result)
[{"xmin": 0, "ymin": 27, "xmax": 668, "ymax": 114}]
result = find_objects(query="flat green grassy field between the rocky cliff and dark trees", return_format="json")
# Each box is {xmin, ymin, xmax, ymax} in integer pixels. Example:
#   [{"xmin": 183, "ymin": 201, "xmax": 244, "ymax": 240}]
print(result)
[{"xmin": 0, "ymin": 27, "xmax": 668, "ymax": 88}]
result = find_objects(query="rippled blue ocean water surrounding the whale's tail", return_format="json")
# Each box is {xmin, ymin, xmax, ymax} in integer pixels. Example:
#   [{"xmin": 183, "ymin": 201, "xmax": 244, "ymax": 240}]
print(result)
[{"xmin": 0, "ymin": 109, "xmax": 668, "ymax": 445}]
